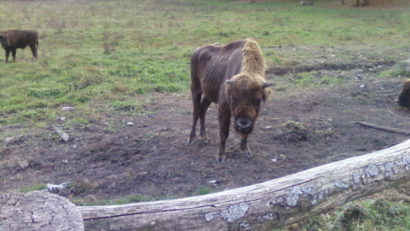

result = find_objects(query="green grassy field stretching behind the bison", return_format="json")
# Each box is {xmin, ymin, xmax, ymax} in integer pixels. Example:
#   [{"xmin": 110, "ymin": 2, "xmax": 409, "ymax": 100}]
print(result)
[{"xmin": 0, "ymin": 0, "xmax": 410, "ymax": 126}]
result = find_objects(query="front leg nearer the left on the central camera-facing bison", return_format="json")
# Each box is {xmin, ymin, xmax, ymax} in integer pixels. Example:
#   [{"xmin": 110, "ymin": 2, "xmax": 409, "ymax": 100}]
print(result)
[{"xmin": 215, "ymin": 105, "xmax": 231, "ymax": 162}]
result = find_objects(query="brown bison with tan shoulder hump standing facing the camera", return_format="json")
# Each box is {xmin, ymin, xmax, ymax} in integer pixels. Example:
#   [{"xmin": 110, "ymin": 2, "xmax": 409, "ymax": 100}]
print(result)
[{"xmin": 188, "ymin": 39, "xmax": 272, "ymax": 162}]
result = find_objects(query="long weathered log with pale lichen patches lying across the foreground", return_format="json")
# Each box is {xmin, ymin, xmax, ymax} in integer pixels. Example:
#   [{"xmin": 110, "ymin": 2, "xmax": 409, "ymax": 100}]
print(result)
[{"xmin": 77, "ymin": 140, "xmax": 410, "ymax": 230}]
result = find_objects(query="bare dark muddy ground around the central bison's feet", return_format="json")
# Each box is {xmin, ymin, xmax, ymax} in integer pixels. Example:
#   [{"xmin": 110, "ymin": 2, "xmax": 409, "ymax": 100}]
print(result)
[{"xmin": 0, "ymin": 47, "xmax": 410, "ymax": 204}]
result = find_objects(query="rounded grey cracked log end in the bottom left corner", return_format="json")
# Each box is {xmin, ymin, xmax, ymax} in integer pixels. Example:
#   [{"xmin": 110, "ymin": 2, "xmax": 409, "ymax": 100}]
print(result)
[{"xmin": 0, "ymin": 191, "xmax": 84, "ymax": 231}]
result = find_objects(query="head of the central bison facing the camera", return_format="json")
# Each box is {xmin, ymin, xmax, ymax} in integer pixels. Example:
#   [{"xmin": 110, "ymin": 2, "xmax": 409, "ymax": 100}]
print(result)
[{"xmin": 225, "ymin": 73, "xmax": 272, "ymax": 135}]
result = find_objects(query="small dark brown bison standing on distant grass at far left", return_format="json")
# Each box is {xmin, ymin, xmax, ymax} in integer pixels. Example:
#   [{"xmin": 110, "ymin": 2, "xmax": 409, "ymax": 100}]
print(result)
[{"xmin": 0, "ymin": 30, "xmax": 38, "ymax": 63}]
